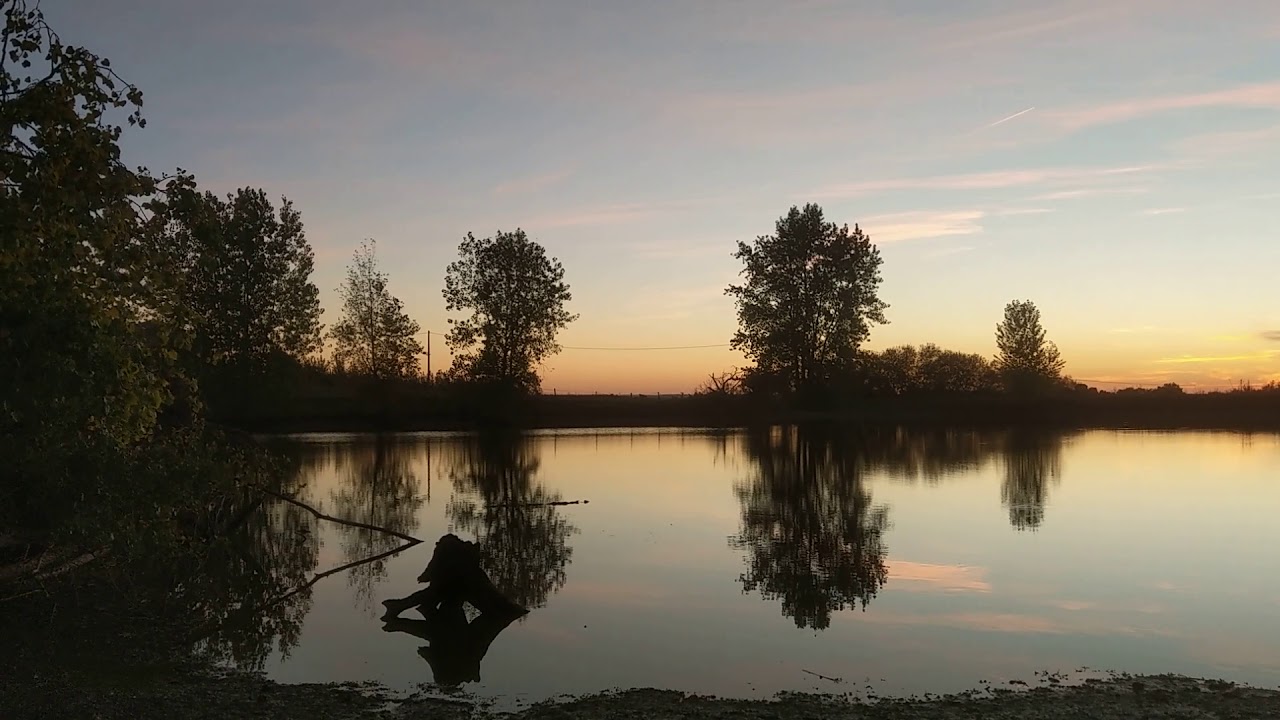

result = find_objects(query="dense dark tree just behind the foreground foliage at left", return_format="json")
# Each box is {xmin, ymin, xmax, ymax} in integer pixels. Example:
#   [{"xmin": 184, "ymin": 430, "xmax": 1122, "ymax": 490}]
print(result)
[{"xmin": 155, "ymin": 184, "xmax": 321, "ymax": 374}]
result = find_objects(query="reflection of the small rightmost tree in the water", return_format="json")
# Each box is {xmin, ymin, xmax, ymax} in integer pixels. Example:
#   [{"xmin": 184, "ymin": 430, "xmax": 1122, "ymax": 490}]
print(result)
[{"xmin": 1000, "ymin": 430, "xmax": 1062, "ymax": 530}]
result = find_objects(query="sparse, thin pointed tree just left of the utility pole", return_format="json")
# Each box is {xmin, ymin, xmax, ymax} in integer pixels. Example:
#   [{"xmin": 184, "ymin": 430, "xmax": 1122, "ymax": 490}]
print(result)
[{"xmin": 329, "ymin": 240, "xmax": 422, "ymax": 378}]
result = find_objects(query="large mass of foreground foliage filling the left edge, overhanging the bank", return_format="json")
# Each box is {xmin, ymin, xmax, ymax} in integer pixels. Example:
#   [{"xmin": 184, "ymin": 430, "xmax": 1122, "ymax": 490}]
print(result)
[{"xmin": 0, "ymin": 0, "xmax": 217, "ymax": 541}]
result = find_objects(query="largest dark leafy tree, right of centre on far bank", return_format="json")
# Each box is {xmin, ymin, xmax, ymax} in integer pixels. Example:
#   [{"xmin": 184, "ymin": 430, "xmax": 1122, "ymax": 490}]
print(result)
[{"xmin": 726, "ymin": 204, "xmax": 888, "ymax": 391}]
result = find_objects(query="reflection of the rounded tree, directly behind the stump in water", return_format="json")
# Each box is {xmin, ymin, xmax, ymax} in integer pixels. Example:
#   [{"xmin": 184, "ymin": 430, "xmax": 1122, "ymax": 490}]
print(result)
[{"xmin": 445, "ymin": 433, "xmax": 577, "ymax": 609}]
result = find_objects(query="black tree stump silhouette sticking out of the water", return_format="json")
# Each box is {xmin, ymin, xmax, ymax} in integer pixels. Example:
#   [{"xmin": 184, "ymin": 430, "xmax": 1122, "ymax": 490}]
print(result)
[{"xmin": 383, "ymin": 533, "xmax": 529, "ymax": 620}]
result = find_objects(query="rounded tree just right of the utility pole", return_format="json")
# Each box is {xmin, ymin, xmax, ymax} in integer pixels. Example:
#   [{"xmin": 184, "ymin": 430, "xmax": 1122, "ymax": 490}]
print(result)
[{"xmin": 444, "ymin": 228, "xmax": 577, "ymax": 393}]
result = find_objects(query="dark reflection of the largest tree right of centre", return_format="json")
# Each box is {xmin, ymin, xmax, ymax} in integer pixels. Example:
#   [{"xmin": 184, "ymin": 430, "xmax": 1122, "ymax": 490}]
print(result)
[{"xmin": 731, "ymin": 428, "xmax": 888, "ymax": 630}]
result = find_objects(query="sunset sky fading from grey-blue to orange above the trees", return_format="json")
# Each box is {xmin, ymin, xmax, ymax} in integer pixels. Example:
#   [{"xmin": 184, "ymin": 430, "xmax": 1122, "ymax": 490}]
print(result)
[{"xmin": 42, "ymin": 0, "xmax": 1280, "ymax": 393}]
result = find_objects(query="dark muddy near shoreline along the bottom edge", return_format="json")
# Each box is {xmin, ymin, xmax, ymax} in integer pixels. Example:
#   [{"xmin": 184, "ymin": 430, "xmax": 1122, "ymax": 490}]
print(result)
[{"xmin": 0, "ymin": 671, "xmax": 1280, "ymax": 720}]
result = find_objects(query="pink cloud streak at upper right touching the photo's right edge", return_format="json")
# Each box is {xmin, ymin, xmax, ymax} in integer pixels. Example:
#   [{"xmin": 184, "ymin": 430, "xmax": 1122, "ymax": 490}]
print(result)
[{"xmin": 1043, "ymin": 82, "xmax": 1280, "ymax": 131}]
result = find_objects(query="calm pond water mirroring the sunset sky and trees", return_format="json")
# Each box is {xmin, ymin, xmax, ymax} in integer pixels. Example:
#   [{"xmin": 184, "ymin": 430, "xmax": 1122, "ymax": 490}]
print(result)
[{"xmin": 220, "ymin": 428, "xmax": 1280, "ymax": 702}]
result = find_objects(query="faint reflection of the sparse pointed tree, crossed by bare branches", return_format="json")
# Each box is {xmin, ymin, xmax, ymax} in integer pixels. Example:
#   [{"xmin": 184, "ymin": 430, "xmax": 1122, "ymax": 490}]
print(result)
[{"xmin": 330, "ymin": 436, "xmax": 424, "ymax": 602}]
